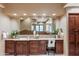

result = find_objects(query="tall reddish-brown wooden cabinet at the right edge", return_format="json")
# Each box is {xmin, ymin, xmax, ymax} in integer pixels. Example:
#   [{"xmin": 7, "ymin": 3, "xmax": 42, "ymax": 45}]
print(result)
[{"xmin": 68, "ymin": 13, "xmax": 79, "ymax": 56}]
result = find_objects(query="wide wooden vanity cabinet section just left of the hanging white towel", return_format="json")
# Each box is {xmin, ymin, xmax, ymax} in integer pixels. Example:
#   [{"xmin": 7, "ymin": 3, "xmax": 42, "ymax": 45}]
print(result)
[{"xmin": 30, "ymin": 40, "xmax": 47, "ymax": 55}]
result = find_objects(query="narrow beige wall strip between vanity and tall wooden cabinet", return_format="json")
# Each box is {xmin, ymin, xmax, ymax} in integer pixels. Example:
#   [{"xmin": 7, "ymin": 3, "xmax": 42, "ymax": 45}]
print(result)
[{"xmin": 60, "ymin": 14, "xmax": 68, "ymax": 55}]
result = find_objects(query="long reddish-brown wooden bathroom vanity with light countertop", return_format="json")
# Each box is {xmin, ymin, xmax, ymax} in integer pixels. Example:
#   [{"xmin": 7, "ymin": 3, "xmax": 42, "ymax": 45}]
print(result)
[{"xmin": 5, "ymin": 38, "xmax": 63, "ymax": 55}]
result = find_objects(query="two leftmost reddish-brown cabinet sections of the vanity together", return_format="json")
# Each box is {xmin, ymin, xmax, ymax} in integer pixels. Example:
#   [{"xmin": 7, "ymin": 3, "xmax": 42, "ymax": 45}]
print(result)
[{"xmin": 5, "ymin": 40, "xmax": 29, "ymax": 55}]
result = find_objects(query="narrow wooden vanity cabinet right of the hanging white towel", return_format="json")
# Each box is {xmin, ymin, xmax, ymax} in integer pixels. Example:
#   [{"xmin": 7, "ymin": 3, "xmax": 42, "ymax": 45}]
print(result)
[{"xmin": 55, "ymin": 40, "xmax": 63, "ymax": 54}]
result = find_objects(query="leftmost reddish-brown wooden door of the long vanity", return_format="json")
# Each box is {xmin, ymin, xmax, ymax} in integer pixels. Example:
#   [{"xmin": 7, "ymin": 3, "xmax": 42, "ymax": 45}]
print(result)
[{"xmin": 5, "ymin": 40, "xmax": 15, "ymax": 55}]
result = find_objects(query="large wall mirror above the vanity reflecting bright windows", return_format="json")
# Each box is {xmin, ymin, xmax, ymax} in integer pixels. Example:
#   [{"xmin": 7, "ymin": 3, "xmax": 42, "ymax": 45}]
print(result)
[{"xmin": 20, "ymin": 16, "xmax": 57, "ymax": 34}]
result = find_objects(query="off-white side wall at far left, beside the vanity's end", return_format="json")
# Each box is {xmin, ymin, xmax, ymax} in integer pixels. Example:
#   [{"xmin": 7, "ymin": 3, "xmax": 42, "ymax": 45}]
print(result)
[{"xmin": 0, "ymin": 9, "xmax": 10, "ymax": 55}]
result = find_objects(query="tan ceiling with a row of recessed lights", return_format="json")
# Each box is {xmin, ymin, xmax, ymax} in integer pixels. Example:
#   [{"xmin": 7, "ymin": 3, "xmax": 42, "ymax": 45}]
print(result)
[{"xmin": 3, "ymin": 3, "xmax": 65, "ymax": 17}]
